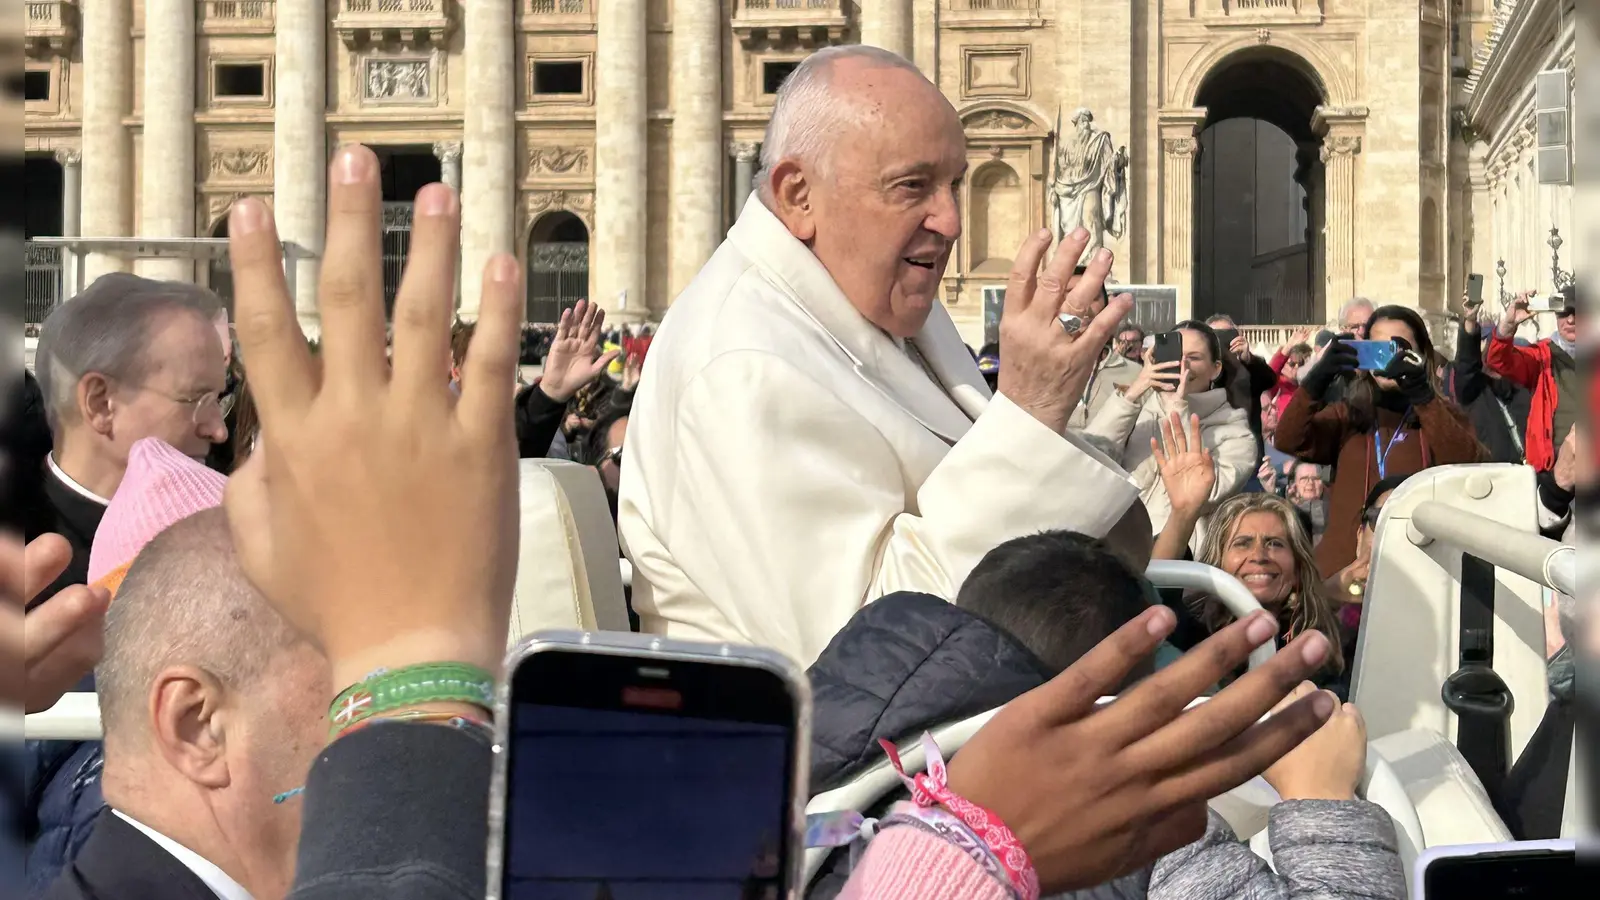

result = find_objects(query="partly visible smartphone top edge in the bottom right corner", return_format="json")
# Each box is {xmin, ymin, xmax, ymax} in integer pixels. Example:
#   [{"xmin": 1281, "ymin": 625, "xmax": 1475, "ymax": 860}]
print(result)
[{"xmin": 1411, "ymin": 841, "xmax": 1578, "ymax": 900}]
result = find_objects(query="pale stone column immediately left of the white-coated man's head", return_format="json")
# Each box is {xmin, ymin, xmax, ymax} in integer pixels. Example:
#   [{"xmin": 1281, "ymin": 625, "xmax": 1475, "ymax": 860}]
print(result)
[{"xmin": 656, "ymin": 3, "xmax": 723, "ymax": 306}]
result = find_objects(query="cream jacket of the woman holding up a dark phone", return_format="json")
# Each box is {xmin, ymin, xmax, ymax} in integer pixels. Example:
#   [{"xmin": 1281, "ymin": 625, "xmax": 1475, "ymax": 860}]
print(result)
[{"xmin": 1083, "ymin": 388, "xmax": 1261, "ymax": 551}]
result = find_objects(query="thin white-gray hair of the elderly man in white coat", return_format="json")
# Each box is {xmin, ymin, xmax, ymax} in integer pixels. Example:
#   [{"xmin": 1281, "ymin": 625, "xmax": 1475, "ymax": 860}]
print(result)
[{"xmin": 755, "ymin": 43, "xmax": 922, "ymax": 203}]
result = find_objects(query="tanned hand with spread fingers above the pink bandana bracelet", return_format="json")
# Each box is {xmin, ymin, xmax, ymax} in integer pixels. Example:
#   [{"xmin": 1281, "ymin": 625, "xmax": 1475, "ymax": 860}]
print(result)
[{"xmin": 949, "ymin": 607, "xmax": 1338, "ymax": 895}]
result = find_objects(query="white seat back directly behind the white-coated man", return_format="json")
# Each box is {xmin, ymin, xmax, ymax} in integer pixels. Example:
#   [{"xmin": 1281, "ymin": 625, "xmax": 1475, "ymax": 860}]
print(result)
[{"xmin": 507, "ymin": 460, "xmax": 629, "ymax": 645}]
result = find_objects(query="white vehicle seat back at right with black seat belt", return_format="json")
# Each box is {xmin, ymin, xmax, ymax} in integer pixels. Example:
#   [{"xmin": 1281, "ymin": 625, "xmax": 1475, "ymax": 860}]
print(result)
[{"xmin": 1350, "ymin": 464, "xmax": 1547, "ymax": 755}]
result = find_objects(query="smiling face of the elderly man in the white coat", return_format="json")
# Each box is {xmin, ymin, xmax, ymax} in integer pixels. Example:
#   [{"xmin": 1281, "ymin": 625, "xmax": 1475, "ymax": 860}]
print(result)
[{"xmin": 774, "ymin": 61, "xmax": 966, "ymax": 338}]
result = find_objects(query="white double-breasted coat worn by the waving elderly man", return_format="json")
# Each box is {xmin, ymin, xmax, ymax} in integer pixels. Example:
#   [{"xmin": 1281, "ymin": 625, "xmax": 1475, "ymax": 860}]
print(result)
[{"xmin": 618, "ymin": 195, "xmax": 1138, "ymax": 665}]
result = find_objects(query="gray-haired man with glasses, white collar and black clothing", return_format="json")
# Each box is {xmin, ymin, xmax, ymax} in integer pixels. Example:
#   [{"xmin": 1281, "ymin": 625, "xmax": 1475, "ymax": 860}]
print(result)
[{"xmin": 24, "ymin": 272, "xmax": 230, "ymax": 602}]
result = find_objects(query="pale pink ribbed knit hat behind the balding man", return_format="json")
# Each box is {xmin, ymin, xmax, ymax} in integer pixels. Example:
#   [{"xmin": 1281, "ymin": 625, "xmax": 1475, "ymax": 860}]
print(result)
[{"xmin": 88, "ymin": 437, "xmax": 227, "ymax": 594}]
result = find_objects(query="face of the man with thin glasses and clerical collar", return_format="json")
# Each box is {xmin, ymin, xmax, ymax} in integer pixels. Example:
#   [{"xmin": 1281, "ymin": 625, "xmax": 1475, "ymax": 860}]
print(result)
[{"xmin": 109, "ymin": 314, "xmax": 227, "ymax": 460}]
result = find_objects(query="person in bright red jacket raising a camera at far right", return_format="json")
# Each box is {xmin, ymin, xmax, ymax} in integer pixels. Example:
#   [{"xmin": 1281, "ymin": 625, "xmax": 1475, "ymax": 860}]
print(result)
[{"xmin": 1486, "ymin": 285, "xmax": 1584, "ymax": 472}]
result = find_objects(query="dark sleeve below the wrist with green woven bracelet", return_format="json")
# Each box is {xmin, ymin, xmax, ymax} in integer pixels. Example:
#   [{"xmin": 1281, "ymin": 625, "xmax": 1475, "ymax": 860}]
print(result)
[{"xmin": 294, "ymin": 724, "xmax": 493, "ymax": 897}]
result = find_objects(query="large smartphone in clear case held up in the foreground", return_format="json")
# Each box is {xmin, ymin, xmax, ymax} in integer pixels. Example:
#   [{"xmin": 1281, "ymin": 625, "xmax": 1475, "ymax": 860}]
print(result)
[{"xmin": 488, "ymin": 631, "xmax": 811, "ymax": 900}]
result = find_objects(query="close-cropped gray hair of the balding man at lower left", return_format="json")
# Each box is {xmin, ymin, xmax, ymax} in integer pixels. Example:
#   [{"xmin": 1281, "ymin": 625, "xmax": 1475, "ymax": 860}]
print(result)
[{"xmin": 94, "ymin": 508, "xmax": 302, "ymax": 746}]
